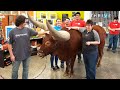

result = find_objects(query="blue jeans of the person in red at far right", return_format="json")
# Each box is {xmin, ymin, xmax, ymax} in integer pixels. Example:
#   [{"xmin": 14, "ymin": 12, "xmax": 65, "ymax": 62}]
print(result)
[{"xmin": 108, "ymin": 34, "xmax": 119, "ymax": 50}]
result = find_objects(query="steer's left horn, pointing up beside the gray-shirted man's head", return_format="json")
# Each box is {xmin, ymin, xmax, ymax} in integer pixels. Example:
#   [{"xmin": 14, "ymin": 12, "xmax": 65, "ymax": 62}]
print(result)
[{"xmin": 27, "ymin": 12, "xmax": 48, "ymax": 30}]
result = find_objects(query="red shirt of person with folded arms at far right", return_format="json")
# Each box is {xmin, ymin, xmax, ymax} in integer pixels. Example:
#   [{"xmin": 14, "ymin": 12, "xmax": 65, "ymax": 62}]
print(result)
[{"xmin": 109, "ymin": 22, "xmax": 120, "ymax": 35}]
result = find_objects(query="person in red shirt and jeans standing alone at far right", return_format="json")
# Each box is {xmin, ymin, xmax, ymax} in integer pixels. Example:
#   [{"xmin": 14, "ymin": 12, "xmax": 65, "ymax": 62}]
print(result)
[{"xmin": 107, "ymin": 17, "xmax": 120, "ymax": 53}]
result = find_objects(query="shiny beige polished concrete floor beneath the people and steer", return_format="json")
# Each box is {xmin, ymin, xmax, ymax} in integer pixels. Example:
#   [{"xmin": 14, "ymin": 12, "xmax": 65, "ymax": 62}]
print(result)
[{"xmin": 0, "ymin": 48, "xmax": 120, "ymax": 79}]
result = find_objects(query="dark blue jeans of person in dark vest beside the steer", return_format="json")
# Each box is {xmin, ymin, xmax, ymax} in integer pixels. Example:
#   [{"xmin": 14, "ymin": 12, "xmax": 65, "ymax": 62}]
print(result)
[{"xmin": 83, "ymin": 50, "xmax": 98, "ymax": 79}]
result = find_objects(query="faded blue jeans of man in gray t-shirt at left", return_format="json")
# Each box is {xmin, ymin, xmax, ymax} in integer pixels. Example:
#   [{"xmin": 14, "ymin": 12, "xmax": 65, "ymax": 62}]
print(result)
[{"xmin": 12, "ymin": 58, "xmax": 30, "ymax": 79}]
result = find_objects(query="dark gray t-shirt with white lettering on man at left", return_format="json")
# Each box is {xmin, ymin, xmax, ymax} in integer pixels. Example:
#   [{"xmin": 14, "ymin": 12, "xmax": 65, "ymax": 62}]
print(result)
[{"xmin": 9, "ymin": 27, "xmax": 38, "ymax": 60}]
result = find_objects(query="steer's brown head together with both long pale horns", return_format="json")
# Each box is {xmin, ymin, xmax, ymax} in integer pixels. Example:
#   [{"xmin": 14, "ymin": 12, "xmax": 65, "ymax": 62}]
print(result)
[{"xmin": 27, "ymin": 13, "xmax": 70, "ymax": 57}]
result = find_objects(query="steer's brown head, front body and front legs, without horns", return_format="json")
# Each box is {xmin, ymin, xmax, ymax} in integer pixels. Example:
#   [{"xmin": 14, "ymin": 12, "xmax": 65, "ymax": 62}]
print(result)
[{"xmin": 39, "ymin": 30, "xmax": 82, "ymax": 76}]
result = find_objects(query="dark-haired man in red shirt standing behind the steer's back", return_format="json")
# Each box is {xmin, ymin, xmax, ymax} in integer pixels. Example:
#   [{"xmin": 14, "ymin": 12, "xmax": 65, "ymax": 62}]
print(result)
[{"xmin": 70, "ymin": 12, "xmax": 86, "ymax": 63}]
